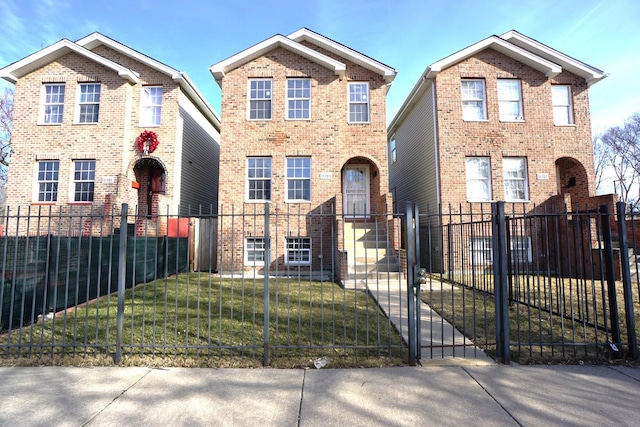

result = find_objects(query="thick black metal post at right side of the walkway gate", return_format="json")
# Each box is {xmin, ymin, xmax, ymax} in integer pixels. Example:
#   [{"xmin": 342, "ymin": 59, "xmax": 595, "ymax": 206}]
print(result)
[{"xmin": 491, "ymin": 202, "xmax": 511, "ymax": 365}]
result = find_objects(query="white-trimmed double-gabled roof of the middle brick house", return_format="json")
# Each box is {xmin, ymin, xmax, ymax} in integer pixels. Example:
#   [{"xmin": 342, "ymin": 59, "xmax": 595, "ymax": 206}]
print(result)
[{"xmin": 209, "ymin": 28, "xmax": 396, "ymax": 84}]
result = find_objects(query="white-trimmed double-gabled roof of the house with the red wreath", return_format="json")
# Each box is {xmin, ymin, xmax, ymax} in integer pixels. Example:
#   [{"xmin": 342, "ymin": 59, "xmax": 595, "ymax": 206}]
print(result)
[{"xmin": 0, "ymin": 32, "xmax": 220, "ymax": 130}]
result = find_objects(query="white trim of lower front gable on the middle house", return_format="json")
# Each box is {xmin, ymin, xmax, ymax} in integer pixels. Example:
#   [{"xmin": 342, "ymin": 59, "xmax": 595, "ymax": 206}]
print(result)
[{"xmin": 209, "ymin": 34, "xmax": 347, "ymax": 84}]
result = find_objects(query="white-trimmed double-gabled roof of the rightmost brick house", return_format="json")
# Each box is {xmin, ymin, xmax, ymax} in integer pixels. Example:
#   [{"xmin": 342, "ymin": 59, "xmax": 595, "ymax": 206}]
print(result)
[{"xmin": 388, "ymin": 30, "xmax": 608, "ymax": 134}]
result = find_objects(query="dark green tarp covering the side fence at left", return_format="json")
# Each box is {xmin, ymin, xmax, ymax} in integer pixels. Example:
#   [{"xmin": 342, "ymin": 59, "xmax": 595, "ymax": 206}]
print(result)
[{"xmin": 0, "ymin": 235, "xmax": 189, "ymax": 329}]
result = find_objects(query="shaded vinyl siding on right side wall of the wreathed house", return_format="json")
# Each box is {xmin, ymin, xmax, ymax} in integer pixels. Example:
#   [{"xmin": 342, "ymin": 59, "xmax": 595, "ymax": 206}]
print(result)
[{"xmin": 180, "ymin": 107, "xmax": 220, "ymax": 216}]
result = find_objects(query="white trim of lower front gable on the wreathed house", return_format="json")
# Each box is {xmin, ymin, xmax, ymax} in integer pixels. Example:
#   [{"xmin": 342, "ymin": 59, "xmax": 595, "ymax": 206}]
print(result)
[{"xmin": 0, "ymin": 39, "xmax": 140, "ymax": 84}]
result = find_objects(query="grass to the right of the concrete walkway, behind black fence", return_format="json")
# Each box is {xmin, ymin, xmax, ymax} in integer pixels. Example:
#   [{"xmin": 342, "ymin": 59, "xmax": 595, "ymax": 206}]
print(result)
[{"xmin": 421, "ymin": 275, "xmax": 640, "ymax": 364}]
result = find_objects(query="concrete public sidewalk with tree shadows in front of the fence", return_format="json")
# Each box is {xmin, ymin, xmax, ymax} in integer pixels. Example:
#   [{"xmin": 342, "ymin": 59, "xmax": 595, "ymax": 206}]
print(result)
[{"xmin": 0, "ymin": 365, "xmax": 640, "ymax": 427}]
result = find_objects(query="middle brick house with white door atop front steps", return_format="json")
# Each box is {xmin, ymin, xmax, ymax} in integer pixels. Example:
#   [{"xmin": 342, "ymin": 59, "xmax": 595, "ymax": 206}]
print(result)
[{"xmin": 210, "ymin": 28, "xmax": 396, "ymax": 280}]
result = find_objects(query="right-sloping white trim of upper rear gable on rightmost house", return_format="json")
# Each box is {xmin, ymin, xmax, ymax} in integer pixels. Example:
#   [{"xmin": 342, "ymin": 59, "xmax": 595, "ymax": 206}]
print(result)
[{"xmin": 500, "ymin": 30, "xmax": 608, "ymax": 86}]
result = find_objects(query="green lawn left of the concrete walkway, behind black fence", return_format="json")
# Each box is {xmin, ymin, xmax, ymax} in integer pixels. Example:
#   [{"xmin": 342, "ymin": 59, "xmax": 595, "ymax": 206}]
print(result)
[{"xmin": 0, "ymin": 273, "xmax": 405, "ymax": 367}]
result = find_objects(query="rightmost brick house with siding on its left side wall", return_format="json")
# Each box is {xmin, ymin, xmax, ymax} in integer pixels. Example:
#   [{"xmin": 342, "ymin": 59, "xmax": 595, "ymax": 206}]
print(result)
[{"xmin": 388, "ymin": 31, "xmax": 607, "ymax": 269}]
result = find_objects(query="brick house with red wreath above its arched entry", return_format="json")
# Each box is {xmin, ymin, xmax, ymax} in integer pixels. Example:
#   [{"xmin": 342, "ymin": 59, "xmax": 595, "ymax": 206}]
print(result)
[{"xmin": 0, "ymin": 33, "xmax": 220, "ymax": 236}]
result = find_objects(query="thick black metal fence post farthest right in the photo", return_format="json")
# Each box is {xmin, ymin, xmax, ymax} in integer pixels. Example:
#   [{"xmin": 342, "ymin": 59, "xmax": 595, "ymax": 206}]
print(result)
[{"xmin": 616, "ymin": 202, "xmax": 638, "ymax": 360}]
